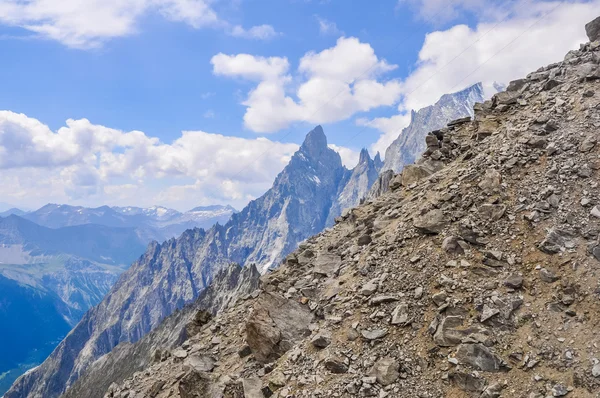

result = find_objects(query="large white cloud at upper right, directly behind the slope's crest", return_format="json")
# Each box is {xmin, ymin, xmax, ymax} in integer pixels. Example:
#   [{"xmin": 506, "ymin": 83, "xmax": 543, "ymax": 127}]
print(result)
[{"xmin": 359, "ymin": 0, "xmax": 600, "ymax": 155}]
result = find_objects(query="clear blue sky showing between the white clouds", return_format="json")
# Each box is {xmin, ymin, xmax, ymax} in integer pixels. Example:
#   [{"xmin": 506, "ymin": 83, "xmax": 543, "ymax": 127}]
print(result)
[{"xmin": 0, "ymin": 0, "xmax": 429, "ymax": 148}]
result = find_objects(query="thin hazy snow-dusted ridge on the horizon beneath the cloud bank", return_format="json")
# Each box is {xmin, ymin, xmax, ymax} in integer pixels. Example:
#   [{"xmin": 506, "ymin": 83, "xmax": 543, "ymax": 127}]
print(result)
[{"xmin": 23, "ymin": 204, "xmax": 235, "ymax": 243}]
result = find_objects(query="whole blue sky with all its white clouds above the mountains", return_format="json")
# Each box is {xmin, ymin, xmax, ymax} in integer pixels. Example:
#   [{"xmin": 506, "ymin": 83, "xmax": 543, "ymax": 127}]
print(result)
[{"xmin": 0, "ymin": 0, "xmax": 600, "ymax": 210}]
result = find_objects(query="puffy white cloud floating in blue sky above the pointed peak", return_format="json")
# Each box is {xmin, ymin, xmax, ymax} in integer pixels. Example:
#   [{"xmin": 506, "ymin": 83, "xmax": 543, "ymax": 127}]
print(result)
[{"xmin": 211, "ymin": 37, "xmax": 400, "ymax": 133}]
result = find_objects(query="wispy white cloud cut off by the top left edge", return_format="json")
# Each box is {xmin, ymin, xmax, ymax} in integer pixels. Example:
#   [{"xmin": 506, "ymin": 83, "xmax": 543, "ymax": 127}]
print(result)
[{"xmin": 0, "ymin": 0, "xmax": 274, "ymax": 49}]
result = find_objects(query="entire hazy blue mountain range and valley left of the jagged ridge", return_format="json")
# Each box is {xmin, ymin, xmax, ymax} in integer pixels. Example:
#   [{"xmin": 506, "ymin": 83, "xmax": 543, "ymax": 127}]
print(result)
[{"xmin": 0, "ymin": 204, "xmax": 235, "ymax": 393}]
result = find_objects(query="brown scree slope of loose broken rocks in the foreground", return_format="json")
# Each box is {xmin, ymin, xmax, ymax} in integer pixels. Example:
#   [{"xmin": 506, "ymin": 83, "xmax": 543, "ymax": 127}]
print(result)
[{"xmin": 94, "ymin": 23, "xmax": 600, "ymax": 398}]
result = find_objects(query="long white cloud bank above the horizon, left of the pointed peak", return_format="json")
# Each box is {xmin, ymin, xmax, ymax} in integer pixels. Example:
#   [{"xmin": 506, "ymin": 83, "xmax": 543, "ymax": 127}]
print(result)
[{"xmin": 0, "ymin": 111, "xmax": 298, "ymax": 208}]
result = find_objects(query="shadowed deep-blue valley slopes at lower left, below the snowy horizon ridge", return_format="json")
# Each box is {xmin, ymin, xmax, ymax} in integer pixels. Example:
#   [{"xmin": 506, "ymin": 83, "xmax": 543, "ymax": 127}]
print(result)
[{"xmin": 0, "ymin": 215, "xmax": 146, "ymax": 394}]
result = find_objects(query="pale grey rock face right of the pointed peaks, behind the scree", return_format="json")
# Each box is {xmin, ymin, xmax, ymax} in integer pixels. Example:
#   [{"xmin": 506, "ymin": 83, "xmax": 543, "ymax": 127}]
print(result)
[{"xmin": 382, "ymin": 83, "xmax": 484, "ymax": 173}]
